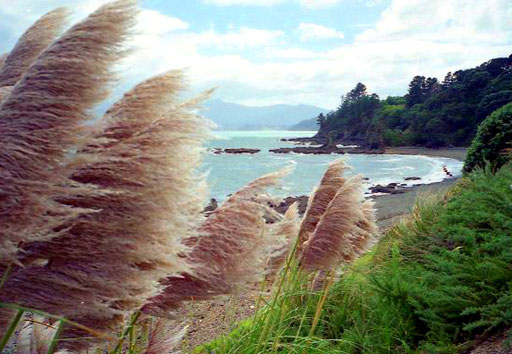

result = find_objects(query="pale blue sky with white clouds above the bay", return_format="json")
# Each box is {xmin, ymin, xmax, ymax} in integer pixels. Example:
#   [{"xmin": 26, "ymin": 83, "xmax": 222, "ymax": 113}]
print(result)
[{"xmin": 0, "ymin": 0, "xmax": 512, "ymax": 109}]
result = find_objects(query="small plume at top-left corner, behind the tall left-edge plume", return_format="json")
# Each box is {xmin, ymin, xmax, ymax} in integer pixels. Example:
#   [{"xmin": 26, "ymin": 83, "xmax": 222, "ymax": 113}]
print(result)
[{"xmin": 0, "ymin": 8, "xmax": 68, "ymax": 87}]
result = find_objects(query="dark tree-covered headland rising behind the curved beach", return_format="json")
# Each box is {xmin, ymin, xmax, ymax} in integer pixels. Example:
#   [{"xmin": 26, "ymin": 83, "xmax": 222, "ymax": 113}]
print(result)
[{"xmin": 318, "ymin": 56, "xmax": 512, "ymax": 147}]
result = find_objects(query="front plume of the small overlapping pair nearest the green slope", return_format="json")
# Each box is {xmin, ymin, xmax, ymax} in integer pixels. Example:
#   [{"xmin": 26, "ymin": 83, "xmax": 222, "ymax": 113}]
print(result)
[{"xmin": 300, "ymin": 175, "xmax": 364, "ymax": 271}]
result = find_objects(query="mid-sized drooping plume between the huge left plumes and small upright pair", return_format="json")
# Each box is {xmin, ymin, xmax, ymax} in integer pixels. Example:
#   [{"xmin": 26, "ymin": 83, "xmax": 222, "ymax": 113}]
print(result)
[{"xmin": 144, "ymin": 168, "xmax": 293, "ymax": 317}]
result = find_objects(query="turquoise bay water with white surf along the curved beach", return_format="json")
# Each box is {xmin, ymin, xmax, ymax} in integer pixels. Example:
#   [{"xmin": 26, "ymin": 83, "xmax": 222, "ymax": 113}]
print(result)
[{"xmin": 202, "ymin": 131, "xmax": 462, "ymax": 200}]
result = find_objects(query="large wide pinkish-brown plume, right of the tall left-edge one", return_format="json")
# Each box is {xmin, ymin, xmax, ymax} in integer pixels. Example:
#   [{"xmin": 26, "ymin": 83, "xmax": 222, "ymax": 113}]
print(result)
[{"xmin": 0, "ymin": 72, "xmax": 208, "ymax": 350}]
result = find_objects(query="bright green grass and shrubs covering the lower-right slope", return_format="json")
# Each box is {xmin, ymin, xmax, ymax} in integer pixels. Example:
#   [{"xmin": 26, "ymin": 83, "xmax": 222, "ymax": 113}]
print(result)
[{"xmin": 201, "ymin": 166, "xmax": 512, "ymax": 353}]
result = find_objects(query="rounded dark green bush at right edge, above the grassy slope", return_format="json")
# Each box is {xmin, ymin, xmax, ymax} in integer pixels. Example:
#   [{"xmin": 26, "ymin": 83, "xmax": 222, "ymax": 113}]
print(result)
[{"xmin": 464, "ymin": 103, "xmax": 512, "ymax": 172}]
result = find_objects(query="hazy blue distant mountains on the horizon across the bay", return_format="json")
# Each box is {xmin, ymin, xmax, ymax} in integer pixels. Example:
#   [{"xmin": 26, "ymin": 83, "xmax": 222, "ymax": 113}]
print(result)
[{"xmin": 203, "ymin": 99, "xmax": 328, "ymax": 130}]
